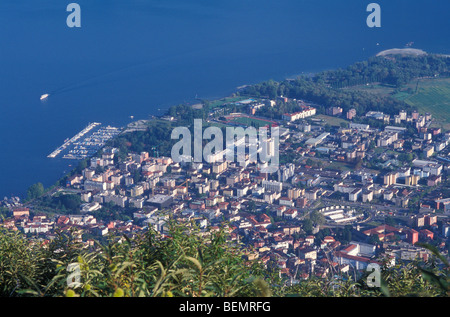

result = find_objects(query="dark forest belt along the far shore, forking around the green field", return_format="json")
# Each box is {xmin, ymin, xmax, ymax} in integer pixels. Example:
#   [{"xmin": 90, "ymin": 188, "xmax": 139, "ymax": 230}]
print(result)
[{"xmin": 240, "ymin": 55, "xmax": 450, "ymax": 117}]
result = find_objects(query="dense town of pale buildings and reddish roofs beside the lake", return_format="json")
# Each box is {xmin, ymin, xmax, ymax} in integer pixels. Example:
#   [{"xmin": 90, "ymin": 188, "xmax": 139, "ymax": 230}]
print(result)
[{"xmin": 0, "ymin": 97, "xmax": 450, "ymax": 283}]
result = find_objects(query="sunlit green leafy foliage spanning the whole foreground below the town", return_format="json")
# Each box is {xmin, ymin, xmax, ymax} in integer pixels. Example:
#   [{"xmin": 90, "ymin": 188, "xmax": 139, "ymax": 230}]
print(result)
[{"xmin": 0, "ymin": 222, "xmax": 449, "ymax": 297}]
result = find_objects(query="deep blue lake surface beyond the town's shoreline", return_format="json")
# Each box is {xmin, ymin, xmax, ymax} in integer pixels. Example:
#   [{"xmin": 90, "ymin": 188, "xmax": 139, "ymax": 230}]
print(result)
[{"xmin": 0, "ymin": 0, "xmax": 450, "ymax": 198}]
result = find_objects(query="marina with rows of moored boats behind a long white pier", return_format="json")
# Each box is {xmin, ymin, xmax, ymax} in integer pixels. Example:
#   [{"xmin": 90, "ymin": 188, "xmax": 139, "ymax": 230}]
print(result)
[{"xmin": 47, "ymin": 122, "xmax": 121, "ymax": 160}]
